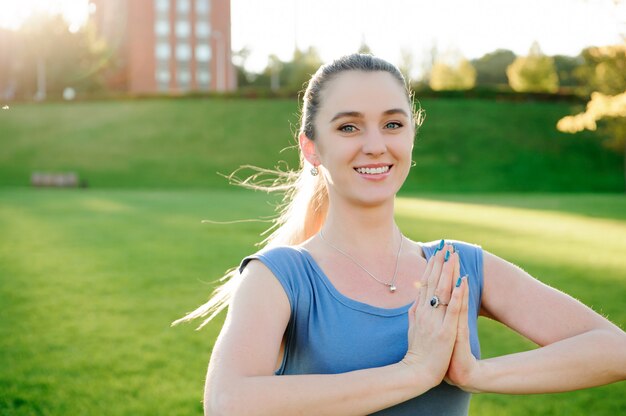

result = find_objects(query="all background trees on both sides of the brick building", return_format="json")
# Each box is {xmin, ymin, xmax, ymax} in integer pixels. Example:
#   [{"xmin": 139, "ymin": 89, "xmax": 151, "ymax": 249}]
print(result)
[{"xmin": 0, "ymin": 15, "xmax": 626, "ymax": 100}]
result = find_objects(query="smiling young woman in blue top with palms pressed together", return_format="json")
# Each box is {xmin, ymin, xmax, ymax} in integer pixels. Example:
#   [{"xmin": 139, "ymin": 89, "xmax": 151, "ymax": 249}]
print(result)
[{"xmin": 174, "ymin": 54, "xmax": 626, "ymax": 416}]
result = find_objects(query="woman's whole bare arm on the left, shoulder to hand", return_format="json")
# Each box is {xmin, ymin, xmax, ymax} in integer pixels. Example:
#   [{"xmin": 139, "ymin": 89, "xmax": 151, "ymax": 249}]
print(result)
[{"xmin": 204, "ymin": 250, "xmax": 467, "ymax": 416}]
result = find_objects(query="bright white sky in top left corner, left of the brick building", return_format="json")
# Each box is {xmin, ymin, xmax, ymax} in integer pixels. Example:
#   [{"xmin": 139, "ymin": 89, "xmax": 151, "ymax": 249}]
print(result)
[{"xmin": 0, "ymin": 0, "xmax": 89, "ymax": 31}]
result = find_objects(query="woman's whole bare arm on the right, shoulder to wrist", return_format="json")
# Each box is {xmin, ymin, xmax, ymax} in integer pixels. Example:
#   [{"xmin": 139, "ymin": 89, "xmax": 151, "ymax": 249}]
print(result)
[{"xmin": 448, "ymin": 252, "xmax": 626, "ymax": 394}]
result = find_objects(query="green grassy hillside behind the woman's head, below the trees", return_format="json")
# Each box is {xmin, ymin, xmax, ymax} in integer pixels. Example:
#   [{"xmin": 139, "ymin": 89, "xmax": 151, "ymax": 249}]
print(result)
[{"xmin": 0, "ymin": 99, "xmax": 624, "ymax": 192}]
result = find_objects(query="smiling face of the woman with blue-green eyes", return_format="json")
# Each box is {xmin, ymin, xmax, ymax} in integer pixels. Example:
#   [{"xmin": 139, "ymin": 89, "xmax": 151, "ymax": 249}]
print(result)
[{"xmin": 314, "ymin": 71, "xmax": 415, "ymax": 206}]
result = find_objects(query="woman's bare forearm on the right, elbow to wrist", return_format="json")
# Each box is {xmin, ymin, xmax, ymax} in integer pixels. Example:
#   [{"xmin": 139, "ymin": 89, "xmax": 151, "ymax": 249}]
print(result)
[{"xmin": 462, "ymin": 329, "xmax": 626, "ymax": 394}]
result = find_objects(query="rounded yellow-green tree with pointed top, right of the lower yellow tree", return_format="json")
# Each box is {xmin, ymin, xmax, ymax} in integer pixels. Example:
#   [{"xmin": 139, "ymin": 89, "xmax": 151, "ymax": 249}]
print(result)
[{"xmin": 506, "ymin": 42, "xmax": 559, "ymax": 92}]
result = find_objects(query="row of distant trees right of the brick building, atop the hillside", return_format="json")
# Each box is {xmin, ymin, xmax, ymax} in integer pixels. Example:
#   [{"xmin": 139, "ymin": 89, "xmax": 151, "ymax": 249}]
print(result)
[{"xmin": 233, "ymin": 42, "xmax": 596, "ymax": 94}]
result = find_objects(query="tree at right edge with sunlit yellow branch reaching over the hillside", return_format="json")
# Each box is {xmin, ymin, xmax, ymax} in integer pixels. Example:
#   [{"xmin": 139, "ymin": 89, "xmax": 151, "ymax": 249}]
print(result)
[{"xmin": 557, "ymin": 42, "xmax": 626, "ymax": 190}]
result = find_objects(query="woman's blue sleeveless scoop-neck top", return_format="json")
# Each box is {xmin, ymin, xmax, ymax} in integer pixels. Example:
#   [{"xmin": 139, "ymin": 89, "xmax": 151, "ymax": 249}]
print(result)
[{"xmin": 240, "ymin": 240, "xmax": 483, "ymax": 416}]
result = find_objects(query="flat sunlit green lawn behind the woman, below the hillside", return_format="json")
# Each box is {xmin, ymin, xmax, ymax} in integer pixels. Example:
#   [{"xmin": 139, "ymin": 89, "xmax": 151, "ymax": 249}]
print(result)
[{"xmin": 0, "ymin": 188, "xmax": 626, "ymax": 416}]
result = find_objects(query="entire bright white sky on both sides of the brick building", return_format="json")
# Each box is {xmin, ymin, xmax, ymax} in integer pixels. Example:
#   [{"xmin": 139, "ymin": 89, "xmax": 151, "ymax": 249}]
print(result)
[{"xmin": 0, "ymin": 0, "xmax": 626, "ymax": 73}]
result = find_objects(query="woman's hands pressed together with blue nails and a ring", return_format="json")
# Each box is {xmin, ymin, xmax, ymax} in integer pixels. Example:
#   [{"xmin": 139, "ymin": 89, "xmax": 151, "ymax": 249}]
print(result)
[{"xmin": 402, "ymin": 244, "xmax": 479, "ymax": 391}]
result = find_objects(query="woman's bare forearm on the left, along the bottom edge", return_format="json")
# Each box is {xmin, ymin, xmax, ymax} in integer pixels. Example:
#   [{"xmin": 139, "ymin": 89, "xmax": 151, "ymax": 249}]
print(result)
[{"xmin": 205, "ymin": 362, "xmax": 438, "ymax": 416}]
